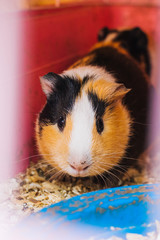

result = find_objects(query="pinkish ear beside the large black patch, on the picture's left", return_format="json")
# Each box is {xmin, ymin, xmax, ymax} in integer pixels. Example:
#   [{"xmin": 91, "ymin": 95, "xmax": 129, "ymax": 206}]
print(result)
[{"xmin": 40, "ymin": 72, "xmax": 59, "ymax": 98}]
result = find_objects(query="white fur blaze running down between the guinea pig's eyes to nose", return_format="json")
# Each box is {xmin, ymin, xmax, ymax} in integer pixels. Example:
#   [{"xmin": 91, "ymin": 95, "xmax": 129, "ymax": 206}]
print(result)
[{"xmin": 69, "ymin": 93, "xmax": 94, "ymax": 163}]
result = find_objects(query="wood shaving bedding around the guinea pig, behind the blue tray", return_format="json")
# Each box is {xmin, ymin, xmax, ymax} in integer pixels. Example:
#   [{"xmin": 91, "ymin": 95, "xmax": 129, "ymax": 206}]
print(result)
[{"xmin": 0, "ymin": 141, "xmax": 160, "ymax": 230}]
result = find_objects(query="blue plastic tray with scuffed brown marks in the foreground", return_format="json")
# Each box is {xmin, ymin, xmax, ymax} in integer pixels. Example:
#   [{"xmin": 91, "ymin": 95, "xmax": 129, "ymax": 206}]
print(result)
[{"xmin": 17, "ymin": 184, "xmax": 160, "ymax": 240}]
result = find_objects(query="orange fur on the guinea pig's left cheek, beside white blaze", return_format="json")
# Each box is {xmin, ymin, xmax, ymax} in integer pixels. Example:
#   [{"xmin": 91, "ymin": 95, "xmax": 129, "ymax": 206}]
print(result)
[{"xmin": 36, "ymin": 115, "xmax": 72, "ymax": 170}]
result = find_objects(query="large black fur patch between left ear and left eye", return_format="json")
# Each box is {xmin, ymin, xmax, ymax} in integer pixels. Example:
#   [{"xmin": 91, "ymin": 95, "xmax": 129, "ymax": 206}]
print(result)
[{"xmin": 39, "ymin": 76, "xmax": 81, "ymax": 131}]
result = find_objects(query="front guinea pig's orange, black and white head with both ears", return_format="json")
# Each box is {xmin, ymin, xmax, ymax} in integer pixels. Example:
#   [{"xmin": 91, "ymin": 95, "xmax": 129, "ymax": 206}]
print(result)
[{"xmin": 36, "ymin": 66, "xmax": 130, "ymax": 177}]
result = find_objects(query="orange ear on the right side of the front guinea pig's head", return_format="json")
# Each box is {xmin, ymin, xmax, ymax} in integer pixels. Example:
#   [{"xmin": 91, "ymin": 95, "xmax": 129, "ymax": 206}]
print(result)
[{"xmin": 111, "ymin": 83, "xmax": 131, "ymax": 100}]
